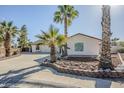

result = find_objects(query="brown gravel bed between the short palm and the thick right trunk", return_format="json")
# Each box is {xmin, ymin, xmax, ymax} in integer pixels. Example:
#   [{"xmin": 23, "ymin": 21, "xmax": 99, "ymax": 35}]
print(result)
[{"xmin": 56, "ymin": 58, "xmax": 99, "ymax": 71}]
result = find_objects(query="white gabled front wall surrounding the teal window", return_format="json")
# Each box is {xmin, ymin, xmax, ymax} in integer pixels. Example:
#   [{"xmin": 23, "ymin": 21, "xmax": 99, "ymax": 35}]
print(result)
[{"xmin": 68, "ymin": 35, "xmax": 100, "ymax": 55}]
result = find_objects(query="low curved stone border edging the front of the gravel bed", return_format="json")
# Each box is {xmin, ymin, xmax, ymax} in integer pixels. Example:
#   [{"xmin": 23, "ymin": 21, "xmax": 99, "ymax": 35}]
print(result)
[{"xmin": 40, "ymin": 63, "xmax": 124, "ymax": 78}]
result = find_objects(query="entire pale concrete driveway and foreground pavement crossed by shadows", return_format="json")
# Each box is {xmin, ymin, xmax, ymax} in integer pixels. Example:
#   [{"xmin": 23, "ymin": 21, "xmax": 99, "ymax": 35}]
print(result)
[{"xmin": 0, "ymin": 54, "xmax": 124, "ymax": 88}]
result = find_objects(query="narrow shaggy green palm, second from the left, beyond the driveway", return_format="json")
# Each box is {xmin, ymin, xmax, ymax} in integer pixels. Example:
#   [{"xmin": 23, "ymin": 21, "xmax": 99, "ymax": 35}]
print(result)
[{"xmin": 17, "ymin": 25, "xmax": 28, "ymax": 50}]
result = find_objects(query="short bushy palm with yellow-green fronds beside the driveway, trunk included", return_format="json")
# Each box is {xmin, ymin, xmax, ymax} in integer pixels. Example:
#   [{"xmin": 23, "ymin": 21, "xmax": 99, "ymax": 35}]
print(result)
[{"xmin": 36, "ymin": 25, "xmax": 66, "ymax": 63}]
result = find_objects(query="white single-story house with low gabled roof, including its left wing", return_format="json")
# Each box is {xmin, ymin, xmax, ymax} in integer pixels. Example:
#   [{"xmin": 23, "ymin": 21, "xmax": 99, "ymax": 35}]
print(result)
[{"xmin": 32, "ymin": 33, "xmax": 101, "ymax": 56}]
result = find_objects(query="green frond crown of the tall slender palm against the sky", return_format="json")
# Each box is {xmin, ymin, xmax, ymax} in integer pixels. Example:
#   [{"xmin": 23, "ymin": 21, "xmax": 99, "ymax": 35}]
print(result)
[{"xmin": 54, "ymin": 5, "xmax": 79, "ymax": 26}]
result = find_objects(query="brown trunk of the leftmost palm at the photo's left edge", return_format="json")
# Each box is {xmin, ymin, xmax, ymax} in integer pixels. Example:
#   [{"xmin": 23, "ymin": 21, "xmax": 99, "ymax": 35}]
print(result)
[{"xmin": 4, "ymin": 32, "xmax": 11, "ymax": 57}]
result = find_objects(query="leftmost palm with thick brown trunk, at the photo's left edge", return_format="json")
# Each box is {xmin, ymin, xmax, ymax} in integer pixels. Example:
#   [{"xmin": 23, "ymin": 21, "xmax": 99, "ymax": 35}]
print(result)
[{"xmin": 0, "ymin": 21, "xmax": 17, "ymax": 57}]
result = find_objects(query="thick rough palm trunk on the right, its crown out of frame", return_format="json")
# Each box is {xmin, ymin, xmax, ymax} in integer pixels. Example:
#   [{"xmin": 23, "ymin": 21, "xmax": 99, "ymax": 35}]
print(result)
[{"xmin": 99, "ymin": 5, "xmax": 113, "ymax": 70}]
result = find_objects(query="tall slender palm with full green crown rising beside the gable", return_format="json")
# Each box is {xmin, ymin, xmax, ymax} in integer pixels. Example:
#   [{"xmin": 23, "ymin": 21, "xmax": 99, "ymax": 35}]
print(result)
[{"xmin": 54, "ymin": 5, "xmax": 79, "ymax": 56}]
